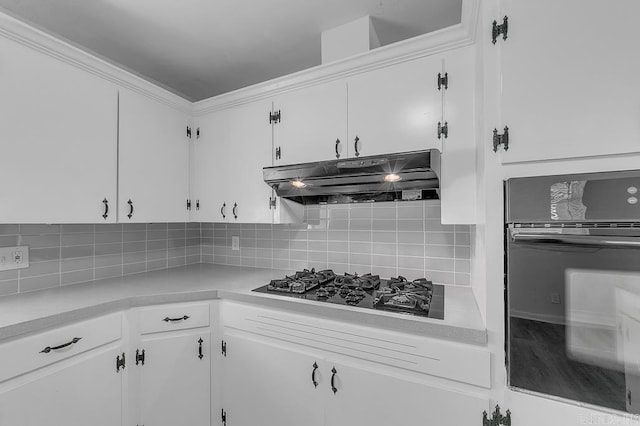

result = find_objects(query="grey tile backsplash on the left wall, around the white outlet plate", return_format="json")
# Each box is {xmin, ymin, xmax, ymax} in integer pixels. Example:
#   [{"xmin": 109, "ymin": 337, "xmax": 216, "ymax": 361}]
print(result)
[{"xmin": 0, "ymin": 223, "xmax": 200, "ymax": 296}]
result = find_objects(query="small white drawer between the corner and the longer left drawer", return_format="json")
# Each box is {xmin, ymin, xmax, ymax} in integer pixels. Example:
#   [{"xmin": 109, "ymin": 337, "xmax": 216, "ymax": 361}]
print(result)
[{"xmin": 139, "ymin": 303, "xmax": 209, "ymax": 334}]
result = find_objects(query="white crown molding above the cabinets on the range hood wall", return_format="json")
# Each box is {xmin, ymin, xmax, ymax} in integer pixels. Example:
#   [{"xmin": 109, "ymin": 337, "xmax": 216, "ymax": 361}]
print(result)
[{"xmin": 193, "ymin": 0, "xmax": 480, "ymax": 117}]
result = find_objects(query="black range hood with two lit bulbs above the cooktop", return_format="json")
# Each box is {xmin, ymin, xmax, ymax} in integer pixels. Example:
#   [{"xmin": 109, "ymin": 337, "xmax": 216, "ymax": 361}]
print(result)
[{"xmin": 263, "ymin": 150, "xmax": 440, "ymax": 204}]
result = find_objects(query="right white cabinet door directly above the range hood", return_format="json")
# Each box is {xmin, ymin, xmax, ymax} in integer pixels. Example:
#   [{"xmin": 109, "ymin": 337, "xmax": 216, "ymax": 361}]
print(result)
[{"xmin": 348, "ymin": 55, "xmax": 442, "ymax": 157}]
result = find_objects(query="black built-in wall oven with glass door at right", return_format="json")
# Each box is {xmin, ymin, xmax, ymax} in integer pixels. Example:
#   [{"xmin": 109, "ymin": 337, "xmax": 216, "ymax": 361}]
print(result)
[{"xmin": 505, "ymin": 171, "xmax": 640, "ymax": 413}]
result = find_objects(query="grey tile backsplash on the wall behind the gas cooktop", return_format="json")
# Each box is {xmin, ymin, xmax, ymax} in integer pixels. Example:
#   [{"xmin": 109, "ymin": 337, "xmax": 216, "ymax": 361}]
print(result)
[{"xmin": 202, "ymin": 200, "xmax": 472, "ymax": 285}]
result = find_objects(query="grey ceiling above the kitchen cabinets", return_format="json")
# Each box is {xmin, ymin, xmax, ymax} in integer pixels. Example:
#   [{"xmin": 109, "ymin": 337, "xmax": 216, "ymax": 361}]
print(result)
[{"xmin": 0, "ymin": 0, "xmax": 462, "ymax": 101}]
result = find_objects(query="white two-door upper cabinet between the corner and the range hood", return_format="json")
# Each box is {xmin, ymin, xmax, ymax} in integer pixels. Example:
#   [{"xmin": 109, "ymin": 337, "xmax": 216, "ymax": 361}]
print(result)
[{"xmin": 191, "ymin": 101, "xmax": 273, "ymax": 223}]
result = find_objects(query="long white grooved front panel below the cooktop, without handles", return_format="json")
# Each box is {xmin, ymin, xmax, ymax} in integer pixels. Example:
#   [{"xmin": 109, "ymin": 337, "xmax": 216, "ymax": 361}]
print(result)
[{"xmin": 221, "ymin": 302, "xmax": 491, "ymax": 388}]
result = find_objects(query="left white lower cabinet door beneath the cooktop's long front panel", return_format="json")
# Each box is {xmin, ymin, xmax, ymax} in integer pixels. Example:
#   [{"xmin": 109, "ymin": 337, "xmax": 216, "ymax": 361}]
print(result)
[{"xmin": 221, "ymin": 334, "xmax": 331, "ymax": 426}]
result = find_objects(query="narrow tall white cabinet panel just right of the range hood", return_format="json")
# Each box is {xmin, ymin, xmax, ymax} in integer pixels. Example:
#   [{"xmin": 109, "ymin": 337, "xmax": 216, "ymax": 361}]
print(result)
[{"xmin": 440, "ymin": 47, "xmax": 477, "ymax": 224}]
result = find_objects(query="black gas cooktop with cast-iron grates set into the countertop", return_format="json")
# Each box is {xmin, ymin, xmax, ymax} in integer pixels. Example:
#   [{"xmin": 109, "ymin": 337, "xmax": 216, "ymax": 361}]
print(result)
[{"xmin": 253, "ymin": 269, "xmax": 444, "ymax": 319}]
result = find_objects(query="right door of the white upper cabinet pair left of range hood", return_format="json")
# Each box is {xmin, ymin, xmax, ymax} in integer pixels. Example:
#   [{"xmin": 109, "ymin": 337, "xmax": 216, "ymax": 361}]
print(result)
[{"xmin": 222, "ymin": 101, "xmax": 273, "ymax": 223}]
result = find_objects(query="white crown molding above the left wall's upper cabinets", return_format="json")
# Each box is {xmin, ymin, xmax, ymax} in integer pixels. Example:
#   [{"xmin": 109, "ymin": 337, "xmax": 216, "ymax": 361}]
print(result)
[{"xmin": 0, "ymin": 12, "xmax": 193, "ymax": 114}]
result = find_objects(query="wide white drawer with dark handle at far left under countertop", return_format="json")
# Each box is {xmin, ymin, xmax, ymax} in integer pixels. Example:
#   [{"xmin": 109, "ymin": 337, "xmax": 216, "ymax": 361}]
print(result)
[{"xmin": 0, "ymin": 313, "xmax": 122, "ymax": 382}]
